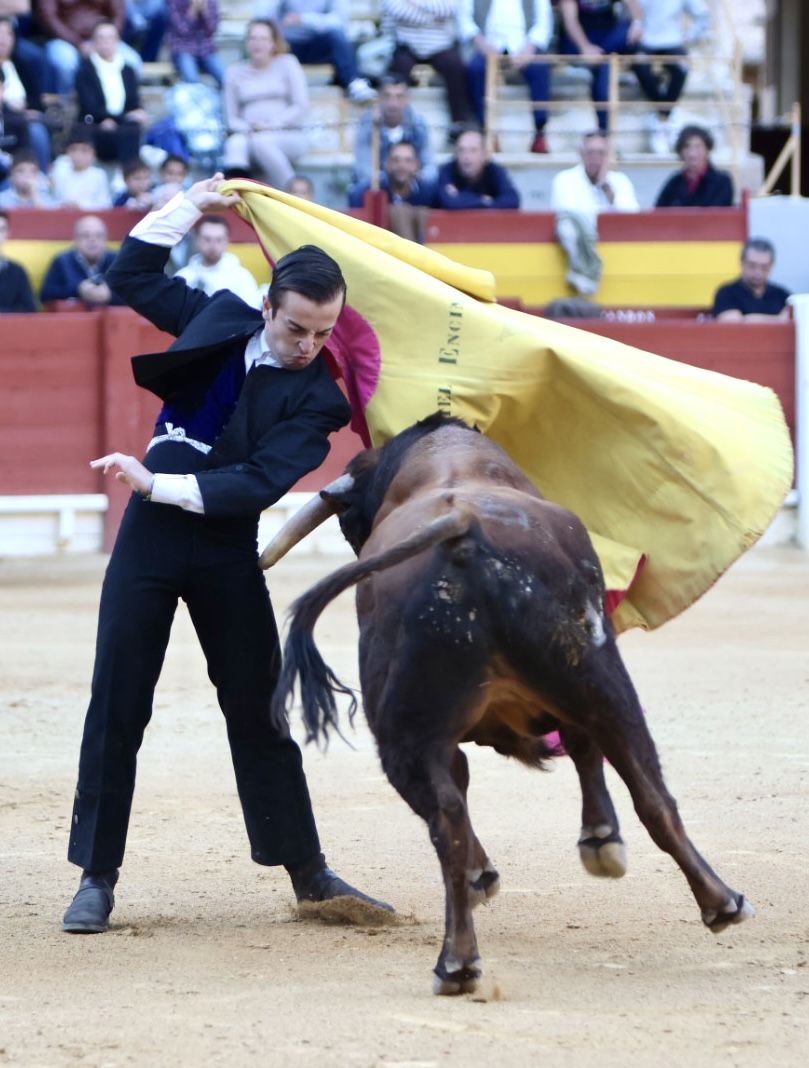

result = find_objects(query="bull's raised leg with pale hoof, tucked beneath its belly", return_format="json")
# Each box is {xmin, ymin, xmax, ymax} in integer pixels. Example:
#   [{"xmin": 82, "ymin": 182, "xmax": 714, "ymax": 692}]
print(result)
[{"xmin": 559, "ymin": 724, "xmax": 626, "ymax": 879}]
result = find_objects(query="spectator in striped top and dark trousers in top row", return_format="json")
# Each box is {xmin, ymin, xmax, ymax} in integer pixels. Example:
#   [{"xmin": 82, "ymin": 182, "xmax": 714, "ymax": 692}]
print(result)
[{"xmin": 382, "ymin": 0, "xmax": 472, "ymax": 134}]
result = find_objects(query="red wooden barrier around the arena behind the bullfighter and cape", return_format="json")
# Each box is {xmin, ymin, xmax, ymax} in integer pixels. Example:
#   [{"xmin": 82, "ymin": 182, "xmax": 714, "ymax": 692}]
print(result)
[{"xmin": 0, "ymin": 308, "xmax": 795, "ymax": 547}]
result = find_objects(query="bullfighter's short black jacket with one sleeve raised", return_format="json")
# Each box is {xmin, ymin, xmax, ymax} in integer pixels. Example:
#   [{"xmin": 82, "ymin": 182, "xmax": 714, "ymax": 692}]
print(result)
[{"xmin": 107, "ymin": 237, "xmax": 351, "ymax": 518}]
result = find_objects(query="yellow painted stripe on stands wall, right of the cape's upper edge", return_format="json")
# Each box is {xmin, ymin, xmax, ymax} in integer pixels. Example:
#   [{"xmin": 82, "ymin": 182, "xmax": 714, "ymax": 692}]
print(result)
[{"xmin": 430, "ymin": 241, "xmax": 742, "ymax": 308}]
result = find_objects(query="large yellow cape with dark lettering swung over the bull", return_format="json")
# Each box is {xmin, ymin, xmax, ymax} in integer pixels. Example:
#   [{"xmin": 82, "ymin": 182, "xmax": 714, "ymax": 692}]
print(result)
[{"xmin": 224, "ymin": 180, "xmax": 792, "ymax": 631}]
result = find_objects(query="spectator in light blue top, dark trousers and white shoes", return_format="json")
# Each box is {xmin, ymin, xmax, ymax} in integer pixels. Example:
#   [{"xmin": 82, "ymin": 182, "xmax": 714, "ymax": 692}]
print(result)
[{"xmin": 633, "ymin": 0, "xmax": 711, "ymax": 156}]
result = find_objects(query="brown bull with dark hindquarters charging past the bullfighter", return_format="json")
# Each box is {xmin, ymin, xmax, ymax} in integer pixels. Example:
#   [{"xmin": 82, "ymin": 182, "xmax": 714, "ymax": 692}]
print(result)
[{"xmin": 268, "ymin": 415, "xmax": 754, "ymax": 994}]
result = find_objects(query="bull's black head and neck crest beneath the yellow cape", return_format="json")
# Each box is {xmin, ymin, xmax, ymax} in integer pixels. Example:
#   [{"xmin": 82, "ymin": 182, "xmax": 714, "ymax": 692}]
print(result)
[{"xmin": 335, "ymin": 411, "xmax": 478, "ymax": 554}]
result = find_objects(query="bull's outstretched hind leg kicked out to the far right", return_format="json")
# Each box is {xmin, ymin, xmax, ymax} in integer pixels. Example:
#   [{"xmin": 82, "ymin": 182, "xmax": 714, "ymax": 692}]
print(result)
[{"xmin": 587, "ymin": 650, "xmax": 756, "ymax": 931}]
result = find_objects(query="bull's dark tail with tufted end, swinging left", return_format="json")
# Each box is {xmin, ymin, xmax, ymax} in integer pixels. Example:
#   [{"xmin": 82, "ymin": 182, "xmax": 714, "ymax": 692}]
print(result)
[{"xmin": 271, "ymin": 507, "xmax": 471, "ymax": 741}]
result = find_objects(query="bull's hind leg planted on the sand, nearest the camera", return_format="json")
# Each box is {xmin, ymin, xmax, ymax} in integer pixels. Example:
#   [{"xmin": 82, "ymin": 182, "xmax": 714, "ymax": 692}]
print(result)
[{"xmin": 377, "ymin": 739, "xmax": 480, "ymax": 994}]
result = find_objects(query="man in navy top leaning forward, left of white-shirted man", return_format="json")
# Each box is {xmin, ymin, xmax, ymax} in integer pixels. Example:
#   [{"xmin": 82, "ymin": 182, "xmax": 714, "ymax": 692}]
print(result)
[{"xmin": 435, "ymin": 128, "xmax": 519, "ymax": 211}]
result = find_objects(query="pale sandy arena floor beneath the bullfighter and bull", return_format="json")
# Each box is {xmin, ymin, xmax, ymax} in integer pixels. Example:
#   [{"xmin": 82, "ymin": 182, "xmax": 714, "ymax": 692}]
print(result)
[{"xmin": 0, "ymin": 549, "xmax": 809, "ymax": 1068}]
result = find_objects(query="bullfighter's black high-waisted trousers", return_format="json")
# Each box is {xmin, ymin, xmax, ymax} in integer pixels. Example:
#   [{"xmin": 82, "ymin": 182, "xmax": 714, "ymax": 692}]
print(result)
[{"xmin": 67, "ymin": 496, "xmax": 320, "ymax": 871}]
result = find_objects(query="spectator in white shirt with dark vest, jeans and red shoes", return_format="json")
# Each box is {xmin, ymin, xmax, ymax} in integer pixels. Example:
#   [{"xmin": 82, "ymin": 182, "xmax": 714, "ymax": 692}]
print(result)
[{"xmin": 461, "ymin": 0, "xmax": 554, "ymax": 153}]
